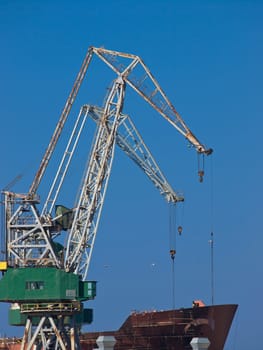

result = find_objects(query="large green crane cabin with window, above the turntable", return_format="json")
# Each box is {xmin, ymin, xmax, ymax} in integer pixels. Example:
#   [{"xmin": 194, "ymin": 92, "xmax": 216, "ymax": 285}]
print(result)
[{"xmin": 0, "ymin": 267, "xmax": 96, "ymax": 303}]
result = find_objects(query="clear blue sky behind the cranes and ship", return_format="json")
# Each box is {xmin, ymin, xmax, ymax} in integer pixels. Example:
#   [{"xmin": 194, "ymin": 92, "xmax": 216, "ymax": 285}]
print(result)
[{"xmin": 0, "ymin": 0, "xmax": 263, "ymax": 350}]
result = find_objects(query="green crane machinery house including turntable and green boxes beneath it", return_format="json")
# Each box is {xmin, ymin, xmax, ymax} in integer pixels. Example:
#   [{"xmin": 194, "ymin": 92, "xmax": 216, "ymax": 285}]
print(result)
[{"xmin": 0, "ymin": 267, "xmax": 96, "ymax": 326}]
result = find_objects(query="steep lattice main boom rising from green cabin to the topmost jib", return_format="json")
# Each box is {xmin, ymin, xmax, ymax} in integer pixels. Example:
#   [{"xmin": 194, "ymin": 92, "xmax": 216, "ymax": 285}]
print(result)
[{"xmin": 65, "ymin": 78, "xmax": 125, "ymax": 279}]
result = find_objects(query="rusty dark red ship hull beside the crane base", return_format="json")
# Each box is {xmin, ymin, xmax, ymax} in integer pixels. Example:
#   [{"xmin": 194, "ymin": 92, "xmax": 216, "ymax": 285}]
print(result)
[{"xmin": 81, "ymin": 304, "xmax": 237, "ymax": 350}]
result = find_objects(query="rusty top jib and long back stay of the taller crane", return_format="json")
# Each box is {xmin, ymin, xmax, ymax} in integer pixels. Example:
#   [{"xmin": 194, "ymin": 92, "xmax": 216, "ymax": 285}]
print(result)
[{"xmin": 28, "ymin": 46, "xmax": 213, "ymax": 198}]
